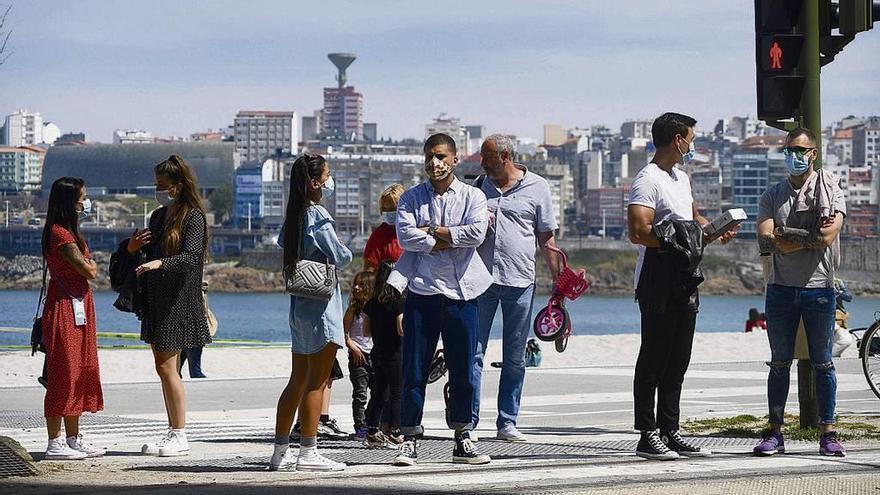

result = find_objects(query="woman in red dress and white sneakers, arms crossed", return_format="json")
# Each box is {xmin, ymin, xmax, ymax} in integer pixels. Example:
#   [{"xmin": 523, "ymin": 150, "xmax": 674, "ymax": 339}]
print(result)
[{"xmin": 42, "ymin": 177, "xmax": 106, "ymax": 460}]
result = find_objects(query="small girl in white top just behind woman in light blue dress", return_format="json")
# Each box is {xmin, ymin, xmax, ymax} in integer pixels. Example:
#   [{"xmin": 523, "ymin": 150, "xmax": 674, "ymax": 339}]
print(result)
[{"xmin": 342, "ymin": 272, "xmax": 373, "ymax": 442}]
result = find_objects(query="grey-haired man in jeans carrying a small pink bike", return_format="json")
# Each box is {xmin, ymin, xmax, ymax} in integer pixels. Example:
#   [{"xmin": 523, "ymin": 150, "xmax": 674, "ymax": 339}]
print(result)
[{"xmin": 472, "ymin": 134, "xmax": 559, "ymax": 442}]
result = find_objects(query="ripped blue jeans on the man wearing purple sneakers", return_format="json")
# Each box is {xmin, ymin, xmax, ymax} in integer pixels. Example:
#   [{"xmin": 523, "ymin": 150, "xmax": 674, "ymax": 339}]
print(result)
[{"xmin": 765, "ymin": 284, "xmax": 837, "ymax": 425}]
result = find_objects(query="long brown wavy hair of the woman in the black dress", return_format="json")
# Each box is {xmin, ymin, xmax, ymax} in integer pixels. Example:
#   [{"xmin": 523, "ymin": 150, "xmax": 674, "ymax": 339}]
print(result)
[{"xmin": 153, "ymin": 155, "xmax": 208, "ymax": 256}]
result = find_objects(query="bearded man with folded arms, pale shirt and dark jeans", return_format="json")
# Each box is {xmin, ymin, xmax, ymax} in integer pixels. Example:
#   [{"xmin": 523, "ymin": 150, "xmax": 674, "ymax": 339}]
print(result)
[{"xmin": 388, "ymin": 134, "xmax": 492, "ymax": 466}]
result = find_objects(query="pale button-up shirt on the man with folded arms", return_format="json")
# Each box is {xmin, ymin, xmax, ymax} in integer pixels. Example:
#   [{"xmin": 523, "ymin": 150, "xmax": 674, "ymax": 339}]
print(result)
[{"xmin": 388, "ymin": 179, "xmax": 492, "ymax": 301}]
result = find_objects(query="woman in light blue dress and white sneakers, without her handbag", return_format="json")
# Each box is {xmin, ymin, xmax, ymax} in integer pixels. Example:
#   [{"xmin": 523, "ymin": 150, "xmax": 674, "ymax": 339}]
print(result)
[{"xmin": 269, "ymin": 154, "xmax": 352, "ymax": 471}]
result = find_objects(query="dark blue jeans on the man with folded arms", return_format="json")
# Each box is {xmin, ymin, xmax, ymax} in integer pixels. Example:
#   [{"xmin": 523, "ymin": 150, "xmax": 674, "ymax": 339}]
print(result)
[{"xmin": 400, "ymin": 292, "xmax": 479, "ymax": 436}]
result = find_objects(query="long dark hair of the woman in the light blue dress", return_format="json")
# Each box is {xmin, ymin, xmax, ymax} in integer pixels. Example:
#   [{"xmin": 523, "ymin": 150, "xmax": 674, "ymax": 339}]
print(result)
[{"xmin": 282, "ymin": 153, "xmax": 327, "ymax": 268}]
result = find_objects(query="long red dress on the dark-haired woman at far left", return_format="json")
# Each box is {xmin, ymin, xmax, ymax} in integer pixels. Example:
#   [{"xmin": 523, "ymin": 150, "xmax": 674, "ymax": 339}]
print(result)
[{"xmin": 43, "ymin": 225, "xmax": 104, "ymax": 417}]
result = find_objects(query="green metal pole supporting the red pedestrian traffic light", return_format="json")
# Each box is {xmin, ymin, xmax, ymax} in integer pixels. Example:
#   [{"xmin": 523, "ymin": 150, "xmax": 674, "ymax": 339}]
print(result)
[{"xmin": 797, "ymin": 0, "xmax": 822, "ymax": 428}]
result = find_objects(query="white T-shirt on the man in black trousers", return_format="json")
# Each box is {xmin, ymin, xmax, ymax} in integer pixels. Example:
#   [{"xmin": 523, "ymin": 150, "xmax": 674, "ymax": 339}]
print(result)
[{"xmin": 629, "ymin": 163, "xmax": 694, "ymax": 288}]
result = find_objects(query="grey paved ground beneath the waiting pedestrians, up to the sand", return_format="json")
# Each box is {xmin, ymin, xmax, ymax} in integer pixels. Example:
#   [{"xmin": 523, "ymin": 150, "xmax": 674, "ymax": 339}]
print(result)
[{"xmin": 0, "ymin": 360, "xmax": 880, "ymax": 495}]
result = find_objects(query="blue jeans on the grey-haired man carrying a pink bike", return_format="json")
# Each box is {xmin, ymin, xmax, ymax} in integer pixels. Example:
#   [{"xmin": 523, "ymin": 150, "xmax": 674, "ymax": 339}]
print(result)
[{"xmin": 473, "ymin": 284, "xmax": 535, "ymax": 430}]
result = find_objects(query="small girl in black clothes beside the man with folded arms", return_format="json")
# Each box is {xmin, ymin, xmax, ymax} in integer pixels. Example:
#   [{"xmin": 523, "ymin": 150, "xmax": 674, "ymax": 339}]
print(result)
[{"xmin": 364, "ymin": 260, "xmax": 403, "ymax": 448}]
